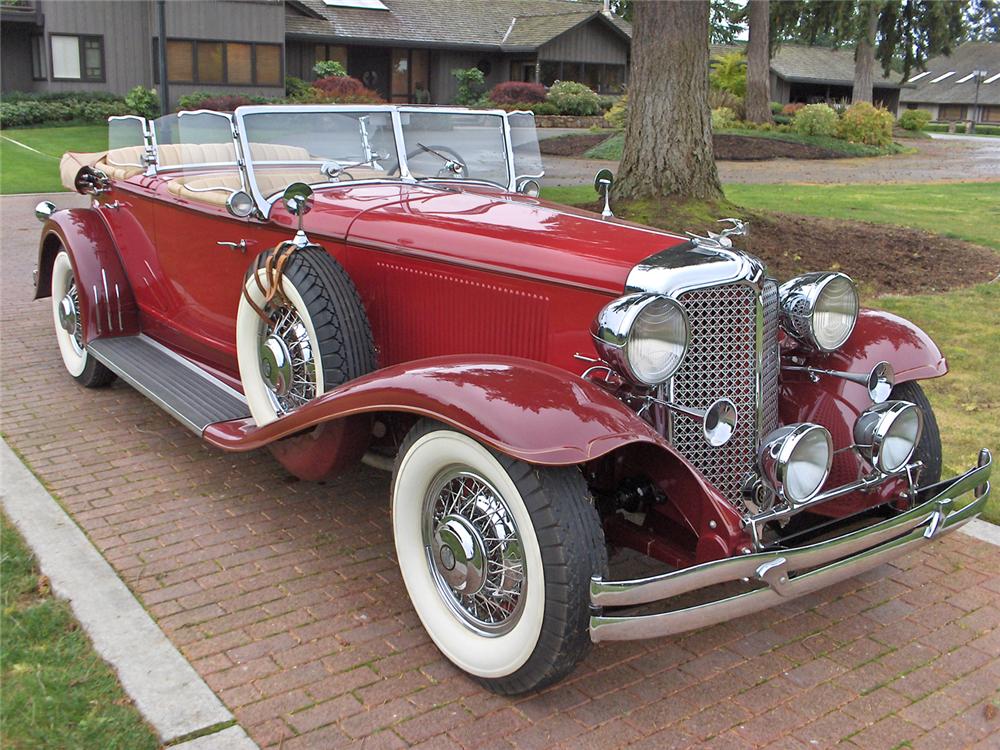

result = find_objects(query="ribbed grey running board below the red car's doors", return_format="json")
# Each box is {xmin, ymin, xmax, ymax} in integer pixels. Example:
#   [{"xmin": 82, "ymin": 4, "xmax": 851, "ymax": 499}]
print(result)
[{"xmin": 87, "ymin": 335, "xmax": 250, "ymax": 435}]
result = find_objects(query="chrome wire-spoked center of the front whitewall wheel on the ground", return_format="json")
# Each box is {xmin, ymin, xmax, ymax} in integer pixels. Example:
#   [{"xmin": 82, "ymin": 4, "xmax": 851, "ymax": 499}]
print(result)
[{"xmin": 423, "ymin": 468, "xmax": 527, "ymax": 636}]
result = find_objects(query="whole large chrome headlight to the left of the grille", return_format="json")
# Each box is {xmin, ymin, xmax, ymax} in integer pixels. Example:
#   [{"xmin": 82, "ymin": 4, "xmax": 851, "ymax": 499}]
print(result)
[{"xmin": 590, "ymin": 292, "xmax": 690, "ymax": 385}]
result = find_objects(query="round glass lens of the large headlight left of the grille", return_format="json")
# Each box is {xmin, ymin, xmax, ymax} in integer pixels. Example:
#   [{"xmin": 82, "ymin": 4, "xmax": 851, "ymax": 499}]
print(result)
[{"xmin": 625, "ymin": 297, "xmax": 688, "ymax": 385}]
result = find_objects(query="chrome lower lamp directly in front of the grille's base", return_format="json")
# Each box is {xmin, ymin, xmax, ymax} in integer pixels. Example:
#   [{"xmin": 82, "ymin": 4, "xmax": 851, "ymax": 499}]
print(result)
[{"xmin": 759, "ymin": 422, "xmax": 833, "ymax": 505}]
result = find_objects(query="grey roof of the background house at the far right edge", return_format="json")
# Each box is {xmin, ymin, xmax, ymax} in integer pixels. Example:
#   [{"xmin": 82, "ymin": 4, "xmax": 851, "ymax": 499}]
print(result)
[{"xmin": 899, "ymin": 42, "xmax": 1000, "ymax": 105}]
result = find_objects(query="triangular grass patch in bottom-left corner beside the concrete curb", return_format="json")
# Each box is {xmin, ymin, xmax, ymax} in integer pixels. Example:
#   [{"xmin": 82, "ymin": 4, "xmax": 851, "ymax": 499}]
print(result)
[{"xmin": 0, "ymin": 515, "xmax": 159, "ymax": 750}]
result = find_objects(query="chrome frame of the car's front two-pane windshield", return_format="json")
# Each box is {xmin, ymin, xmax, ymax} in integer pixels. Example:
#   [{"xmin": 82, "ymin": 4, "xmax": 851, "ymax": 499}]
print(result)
[{"xmin": 233, "ymin": 104, "xmax": 521, "ymax": 217}]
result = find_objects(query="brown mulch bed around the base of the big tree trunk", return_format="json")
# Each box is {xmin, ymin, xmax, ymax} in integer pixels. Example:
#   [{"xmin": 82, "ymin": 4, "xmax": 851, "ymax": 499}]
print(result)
[{"xmin": 580, "ymin": 203, "xmax": 1000, "ymax": 297}]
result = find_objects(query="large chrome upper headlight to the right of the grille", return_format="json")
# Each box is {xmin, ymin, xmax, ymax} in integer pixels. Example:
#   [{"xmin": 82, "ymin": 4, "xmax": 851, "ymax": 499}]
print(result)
[{"xmin": 781, "ymin": 272, "xmax": 858, "ymax": 352}]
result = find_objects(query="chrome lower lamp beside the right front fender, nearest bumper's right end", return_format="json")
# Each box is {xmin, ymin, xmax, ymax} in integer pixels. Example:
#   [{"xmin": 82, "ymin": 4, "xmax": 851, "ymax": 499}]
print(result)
[{"xmin": 854, "ymin": 401, "xmax": 924, "ymax": 474}]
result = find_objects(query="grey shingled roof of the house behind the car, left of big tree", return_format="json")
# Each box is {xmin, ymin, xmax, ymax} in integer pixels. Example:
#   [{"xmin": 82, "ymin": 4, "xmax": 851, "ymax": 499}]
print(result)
[{"xmin": 285, "ymin": 0, "xmax": 632, "ymax": 51}]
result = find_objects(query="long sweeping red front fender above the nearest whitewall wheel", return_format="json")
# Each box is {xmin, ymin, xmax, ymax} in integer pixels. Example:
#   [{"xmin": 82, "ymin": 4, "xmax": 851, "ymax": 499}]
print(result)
[{"xmin": 204, "ymin": 355, "xmax": 745, "ymax": 559}]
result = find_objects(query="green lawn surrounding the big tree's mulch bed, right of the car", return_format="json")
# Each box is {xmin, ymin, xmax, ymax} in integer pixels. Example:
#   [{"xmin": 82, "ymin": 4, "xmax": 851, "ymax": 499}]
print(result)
[{"xmin": 542, "ymin": 182, "xmax": 1000, "ymax": 524}]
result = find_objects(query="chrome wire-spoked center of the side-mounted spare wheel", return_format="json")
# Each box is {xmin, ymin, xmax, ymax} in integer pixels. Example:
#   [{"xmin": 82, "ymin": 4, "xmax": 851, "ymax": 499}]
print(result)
[{"xmin": 259, "ymin": 305, "xmax": 319, "ymax": 415}]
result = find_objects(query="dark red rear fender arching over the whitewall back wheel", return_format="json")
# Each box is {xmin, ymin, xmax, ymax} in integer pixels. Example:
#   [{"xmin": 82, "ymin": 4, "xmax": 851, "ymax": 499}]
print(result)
[{"xmin": 35, "ymin": 208, "xmax": 139, "ymax": 343}]
